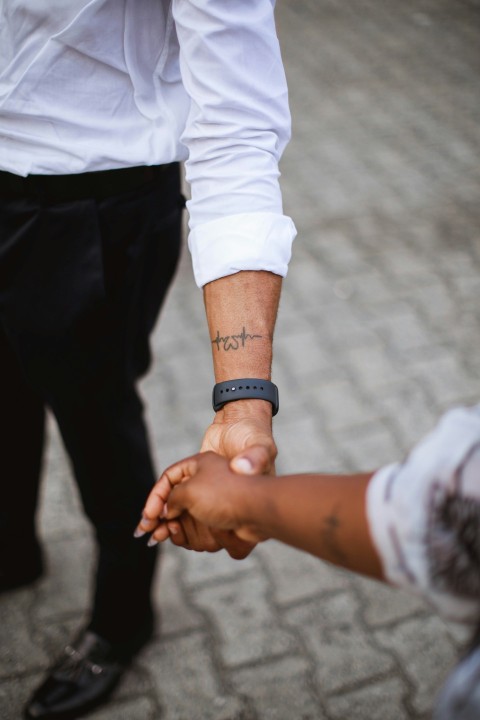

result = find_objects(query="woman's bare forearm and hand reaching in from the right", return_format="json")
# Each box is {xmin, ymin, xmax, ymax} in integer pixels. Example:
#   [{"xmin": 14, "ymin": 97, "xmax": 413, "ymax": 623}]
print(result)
[{"xmin": 137, "ymin": 453, "xmax": 383, "ymax": 578}]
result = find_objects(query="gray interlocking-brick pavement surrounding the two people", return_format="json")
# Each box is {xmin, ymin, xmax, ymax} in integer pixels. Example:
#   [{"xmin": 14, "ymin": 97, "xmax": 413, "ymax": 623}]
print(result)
[{"xmin": 0, "ymin": 0, "xmax": 480, "ymax": 720}]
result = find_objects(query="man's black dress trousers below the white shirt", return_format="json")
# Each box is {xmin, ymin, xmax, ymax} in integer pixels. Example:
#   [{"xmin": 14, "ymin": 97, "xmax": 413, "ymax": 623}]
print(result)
[{"xmin": 0, "ymin": 164, "xmax": 183, "ymax": 641}]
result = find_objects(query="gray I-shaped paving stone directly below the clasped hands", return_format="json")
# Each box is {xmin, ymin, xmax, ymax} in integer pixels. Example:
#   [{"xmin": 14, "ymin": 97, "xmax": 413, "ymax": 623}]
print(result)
[{"xmin": 194, "ymin": 572, "xmax": 296, "ymax": 667}]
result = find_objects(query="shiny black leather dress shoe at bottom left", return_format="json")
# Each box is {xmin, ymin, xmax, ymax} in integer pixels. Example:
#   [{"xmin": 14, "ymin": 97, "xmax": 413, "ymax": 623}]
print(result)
[{"xmin": 25, "ymin": 630, "xmax": 151, "ymax": 720}]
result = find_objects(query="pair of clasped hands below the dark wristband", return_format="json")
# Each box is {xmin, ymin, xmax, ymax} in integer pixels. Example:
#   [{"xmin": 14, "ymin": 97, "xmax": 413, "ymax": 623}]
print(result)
[{"xmin": 134, "ymin": 413, "xmax": 277, "ymax": 560}]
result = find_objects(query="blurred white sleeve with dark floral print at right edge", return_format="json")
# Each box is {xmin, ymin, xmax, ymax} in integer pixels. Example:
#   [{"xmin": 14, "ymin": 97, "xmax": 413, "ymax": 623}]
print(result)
[{"xmin": 367, "ymin": 405, "xmax": 480, "ymax": 623}]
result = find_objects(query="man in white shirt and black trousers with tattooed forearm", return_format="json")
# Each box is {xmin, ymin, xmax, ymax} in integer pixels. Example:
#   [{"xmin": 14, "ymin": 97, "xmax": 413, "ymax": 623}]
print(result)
[{"xmin": 0, "ymin": 0, "xmax": 295, "ymax": 718}]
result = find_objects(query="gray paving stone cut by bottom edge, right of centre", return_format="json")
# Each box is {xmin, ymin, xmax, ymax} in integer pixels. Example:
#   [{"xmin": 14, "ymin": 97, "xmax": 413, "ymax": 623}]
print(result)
[{"xmin": 327, "ymin": 678, "xmax": 412, "ymax": 720}]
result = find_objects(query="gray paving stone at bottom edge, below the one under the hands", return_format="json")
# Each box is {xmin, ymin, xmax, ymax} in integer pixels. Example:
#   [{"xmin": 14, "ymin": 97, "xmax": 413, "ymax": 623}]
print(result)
[{"xmin": 230, "ymin": 656, "xmax": 325, "ymax": 720}]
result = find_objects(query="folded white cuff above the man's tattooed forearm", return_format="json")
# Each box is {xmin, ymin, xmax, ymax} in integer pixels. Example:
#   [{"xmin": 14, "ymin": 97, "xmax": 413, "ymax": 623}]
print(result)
[{"xmin": 188, "ymin": 213, "xmax": 297, "ymax": 287}]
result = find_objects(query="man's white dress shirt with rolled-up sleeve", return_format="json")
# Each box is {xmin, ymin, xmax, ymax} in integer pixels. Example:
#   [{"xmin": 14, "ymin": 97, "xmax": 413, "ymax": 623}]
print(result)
[{"xmin": 0, "ymin": 0, "xmax": 295, "ymax": 286}]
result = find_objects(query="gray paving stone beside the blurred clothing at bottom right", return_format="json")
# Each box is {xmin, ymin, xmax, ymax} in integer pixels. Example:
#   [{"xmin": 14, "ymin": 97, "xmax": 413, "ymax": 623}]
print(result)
[{"xmin": 375, "ymin": 616, "xmax": 458, "ymax": 713}]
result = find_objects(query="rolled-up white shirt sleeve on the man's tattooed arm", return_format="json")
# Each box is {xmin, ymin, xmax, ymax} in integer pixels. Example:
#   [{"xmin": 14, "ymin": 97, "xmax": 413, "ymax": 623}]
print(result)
[{"xmin": 173, "ymin": 0, "xmax": 296, "ymax": 286}]
